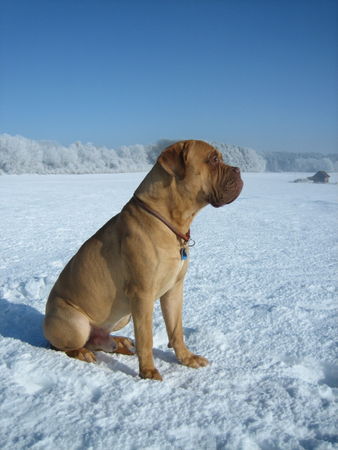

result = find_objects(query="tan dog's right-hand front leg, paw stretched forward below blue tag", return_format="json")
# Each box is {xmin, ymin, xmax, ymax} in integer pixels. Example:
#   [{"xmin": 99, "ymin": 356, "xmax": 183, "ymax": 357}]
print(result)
[{"xmin": 161, "ymin": 279, "xmax": 208, "ymax": 369}]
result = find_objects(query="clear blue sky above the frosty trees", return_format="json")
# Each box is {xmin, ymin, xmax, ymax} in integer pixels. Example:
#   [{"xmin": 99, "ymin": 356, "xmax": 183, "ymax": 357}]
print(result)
[{"xmin": 0, "ymin": 0, "xmax": 338, "ymax": 152}]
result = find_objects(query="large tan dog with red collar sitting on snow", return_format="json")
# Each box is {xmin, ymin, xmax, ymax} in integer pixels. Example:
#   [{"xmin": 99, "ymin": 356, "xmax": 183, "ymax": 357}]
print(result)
[{"xmin": 44, "ymin": 141, "xmax": 243, "ymax": 380}]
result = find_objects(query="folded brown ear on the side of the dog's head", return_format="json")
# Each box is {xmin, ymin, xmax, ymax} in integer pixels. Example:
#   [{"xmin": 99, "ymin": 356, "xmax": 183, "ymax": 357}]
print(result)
[{"xmin": 157, "ymin": 141, "xmax": 189, "ymax": 180}]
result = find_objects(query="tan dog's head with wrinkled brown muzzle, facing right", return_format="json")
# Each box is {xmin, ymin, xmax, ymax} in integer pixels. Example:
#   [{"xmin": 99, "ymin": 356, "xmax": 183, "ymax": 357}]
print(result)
[{"xmin": 157, "ymin": 141, "xmax": 243, "ymax": 208}]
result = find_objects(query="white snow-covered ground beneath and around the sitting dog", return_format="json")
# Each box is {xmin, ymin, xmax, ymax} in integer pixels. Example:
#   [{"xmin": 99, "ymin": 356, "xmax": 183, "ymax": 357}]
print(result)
[{"xmin": 0, "ymin": 173, "xmax": 338, "ymax": 450}]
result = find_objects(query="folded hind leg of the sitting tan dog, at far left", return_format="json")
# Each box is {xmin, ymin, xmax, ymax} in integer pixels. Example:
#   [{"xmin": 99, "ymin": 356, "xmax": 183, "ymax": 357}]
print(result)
[{"xmin": 44, "ymin": 297, "xmax": 96, "ymax": 362}]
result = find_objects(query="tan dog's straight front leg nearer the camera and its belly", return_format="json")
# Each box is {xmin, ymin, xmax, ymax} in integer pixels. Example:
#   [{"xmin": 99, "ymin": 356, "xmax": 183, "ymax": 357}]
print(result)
[{"xmin": 131, "ymin": 297, "xmax": 162, "ymax": 381}]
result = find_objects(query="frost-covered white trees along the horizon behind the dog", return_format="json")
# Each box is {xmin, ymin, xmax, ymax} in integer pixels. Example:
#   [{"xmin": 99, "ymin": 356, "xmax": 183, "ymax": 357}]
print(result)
[{"xmin": 0, "ymin": 134, "xmax": 338, "ymax": 174}]
